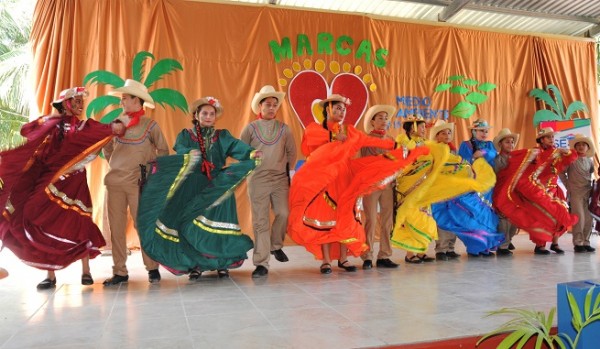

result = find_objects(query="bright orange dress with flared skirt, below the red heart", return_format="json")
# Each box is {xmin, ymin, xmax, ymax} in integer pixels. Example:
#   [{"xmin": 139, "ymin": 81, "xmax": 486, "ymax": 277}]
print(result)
[{"xmin": 288, "ymin": 123, "xmax": 428, "ymax": 259}]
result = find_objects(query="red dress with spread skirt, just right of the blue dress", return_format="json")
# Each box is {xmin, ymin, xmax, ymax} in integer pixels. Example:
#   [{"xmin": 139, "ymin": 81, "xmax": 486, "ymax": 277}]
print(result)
[{"xmin": 493, "ymin": 148, "xmax": 578, "ymax": 244}]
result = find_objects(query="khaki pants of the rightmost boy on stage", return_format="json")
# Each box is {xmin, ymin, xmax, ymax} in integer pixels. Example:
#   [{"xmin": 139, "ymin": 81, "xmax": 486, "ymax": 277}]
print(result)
[{"xmin": 569, "ymin": 187, "xmax": 593, "ymax": 246}]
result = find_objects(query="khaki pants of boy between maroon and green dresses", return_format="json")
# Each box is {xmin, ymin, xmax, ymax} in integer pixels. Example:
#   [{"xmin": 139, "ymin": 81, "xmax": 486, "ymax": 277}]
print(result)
[{"xmin": 106, "ymin": 186, "xmax": 158, "ymax": 276}]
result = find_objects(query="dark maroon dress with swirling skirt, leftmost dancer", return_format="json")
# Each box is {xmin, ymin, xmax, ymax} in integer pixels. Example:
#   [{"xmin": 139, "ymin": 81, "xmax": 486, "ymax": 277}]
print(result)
[{"xmin": 0, "ymin": 116, "xmax": 112, "ymax": 270}]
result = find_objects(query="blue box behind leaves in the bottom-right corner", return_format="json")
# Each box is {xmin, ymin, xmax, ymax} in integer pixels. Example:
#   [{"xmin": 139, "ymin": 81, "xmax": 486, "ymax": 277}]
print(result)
[{"xmin": 557, "ymin": 280, "xmax": 600, "ymax": 349}]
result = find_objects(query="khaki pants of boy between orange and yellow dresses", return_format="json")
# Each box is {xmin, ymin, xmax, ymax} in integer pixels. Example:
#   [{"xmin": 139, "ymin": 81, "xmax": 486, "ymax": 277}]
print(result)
[{"xmin": 360, "ymin": 186, "xmax": 394, "ymax": 260}]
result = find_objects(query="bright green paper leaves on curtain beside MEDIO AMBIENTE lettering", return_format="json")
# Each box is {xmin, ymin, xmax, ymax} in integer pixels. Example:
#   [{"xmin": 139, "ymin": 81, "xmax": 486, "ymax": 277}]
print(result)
[{"xmin": 435, "ymin": 75, "xmax": 496, "ymax": 119}]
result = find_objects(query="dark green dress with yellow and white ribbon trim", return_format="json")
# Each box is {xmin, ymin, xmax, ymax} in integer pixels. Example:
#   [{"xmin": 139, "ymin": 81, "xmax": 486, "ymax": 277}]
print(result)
[{"xmin": 138, "ymin": 128, "xmax": 256, "ymax": 274}]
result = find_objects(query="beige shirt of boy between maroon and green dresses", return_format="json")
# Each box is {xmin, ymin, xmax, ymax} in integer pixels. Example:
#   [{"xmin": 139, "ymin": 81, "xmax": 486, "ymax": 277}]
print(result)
[{"xmin": 103, "ymin": 116, "xmax": 169, "ymax": 186}]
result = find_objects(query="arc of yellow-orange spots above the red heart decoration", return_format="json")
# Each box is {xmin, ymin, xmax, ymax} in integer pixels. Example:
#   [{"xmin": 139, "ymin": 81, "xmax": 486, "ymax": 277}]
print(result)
[{"xmin": 278, "ymin": 58, "xmax": 377, "ymax": 92}]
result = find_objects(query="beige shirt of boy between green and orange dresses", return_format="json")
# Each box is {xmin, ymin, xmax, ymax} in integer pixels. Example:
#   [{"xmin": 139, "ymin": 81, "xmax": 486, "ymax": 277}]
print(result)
[{"xmin": 240, "ymin": 119, "xmax": 296, "ymax": 180}]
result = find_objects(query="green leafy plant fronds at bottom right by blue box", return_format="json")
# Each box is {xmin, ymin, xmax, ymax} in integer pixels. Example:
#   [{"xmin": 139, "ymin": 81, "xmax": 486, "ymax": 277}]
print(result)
[{"xmin": 476, "ymin": 286, "xmax": 600, "ymax": 349}]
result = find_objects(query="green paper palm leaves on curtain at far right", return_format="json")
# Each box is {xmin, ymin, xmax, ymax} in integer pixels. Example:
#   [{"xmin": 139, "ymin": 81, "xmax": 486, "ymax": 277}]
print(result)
[{"xmin": 529, "ymin": 84, "xmax": 588, "ymax": 127}]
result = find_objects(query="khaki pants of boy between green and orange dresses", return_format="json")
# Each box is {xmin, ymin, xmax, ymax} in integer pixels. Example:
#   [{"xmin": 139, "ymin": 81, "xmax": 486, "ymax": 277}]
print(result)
[{"xmin": 248, "ymin": 177, "xmax": 290, "ymax": 268}]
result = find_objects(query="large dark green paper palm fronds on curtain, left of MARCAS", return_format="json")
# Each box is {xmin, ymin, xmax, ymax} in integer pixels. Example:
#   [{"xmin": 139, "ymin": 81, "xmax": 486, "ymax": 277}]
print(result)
[{"xmin": 83, "ymin": 51, "xmax": 188, "ymax": 123}]
